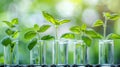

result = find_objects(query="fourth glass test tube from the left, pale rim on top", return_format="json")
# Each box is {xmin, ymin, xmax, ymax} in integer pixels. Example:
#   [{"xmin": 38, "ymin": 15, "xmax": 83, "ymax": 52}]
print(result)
[{"xmin": 74, "ymin": 40, "xmax": 87, "ymax": 65}]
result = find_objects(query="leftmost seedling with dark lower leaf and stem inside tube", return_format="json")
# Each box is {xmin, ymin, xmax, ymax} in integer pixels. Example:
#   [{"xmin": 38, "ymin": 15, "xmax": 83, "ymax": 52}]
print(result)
[{"xmin": 1, "ymin": 18, "xmax": 19, "ymax": 64}]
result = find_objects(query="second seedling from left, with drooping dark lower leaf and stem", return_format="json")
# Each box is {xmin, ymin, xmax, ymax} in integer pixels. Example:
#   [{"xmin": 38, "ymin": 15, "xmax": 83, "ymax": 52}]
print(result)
[{"xmin": 24, "ymin": 24, "xmax": 54, "ymax": 64}]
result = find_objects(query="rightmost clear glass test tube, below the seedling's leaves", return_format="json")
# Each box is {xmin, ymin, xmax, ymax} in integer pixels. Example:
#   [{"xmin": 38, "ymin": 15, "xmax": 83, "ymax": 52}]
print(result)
[{"xmin": 99, "ymin": 40, "xmax": 114, "ymax": 64}]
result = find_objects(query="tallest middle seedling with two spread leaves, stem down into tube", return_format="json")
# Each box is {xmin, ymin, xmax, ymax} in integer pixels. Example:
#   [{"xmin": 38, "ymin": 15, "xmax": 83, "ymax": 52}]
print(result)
[{"xmin": 42, "ymin": 11, "xmax": 70, "ymax": 64}]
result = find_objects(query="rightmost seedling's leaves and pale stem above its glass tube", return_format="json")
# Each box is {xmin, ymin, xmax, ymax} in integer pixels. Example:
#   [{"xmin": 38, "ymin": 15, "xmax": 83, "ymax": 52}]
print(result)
[{"xmin": 93, "ymin": 12, "xmax": 120, "ymax": 39}]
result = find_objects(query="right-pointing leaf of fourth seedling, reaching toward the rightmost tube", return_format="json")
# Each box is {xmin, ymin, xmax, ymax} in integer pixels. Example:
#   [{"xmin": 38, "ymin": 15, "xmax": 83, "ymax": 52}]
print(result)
[{"xmin": 85, "ymin": 29, "xmax": 103, "ymax": 39}]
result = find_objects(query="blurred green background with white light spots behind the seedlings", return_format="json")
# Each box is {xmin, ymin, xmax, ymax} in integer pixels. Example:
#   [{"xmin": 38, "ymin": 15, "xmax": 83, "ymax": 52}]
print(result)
[{"xmin": 0, "ymin": 0, "xmax": 120, "ymax": 64}]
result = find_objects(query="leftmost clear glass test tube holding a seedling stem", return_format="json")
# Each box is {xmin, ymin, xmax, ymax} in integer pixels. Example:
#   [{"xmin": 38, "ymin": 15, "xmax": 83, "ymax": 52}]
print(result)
[{"xmin": 4, "ymin": 41, "xmax": 19, "ymax": 65}]
